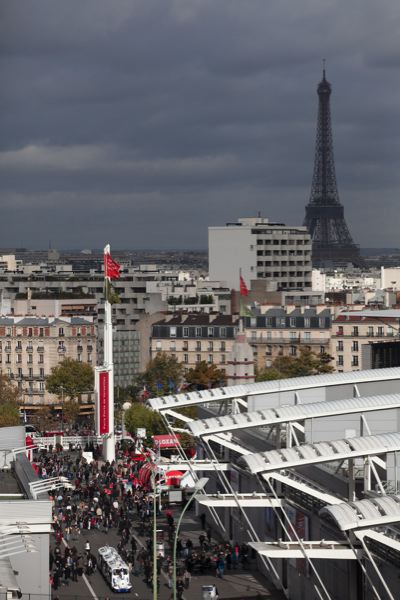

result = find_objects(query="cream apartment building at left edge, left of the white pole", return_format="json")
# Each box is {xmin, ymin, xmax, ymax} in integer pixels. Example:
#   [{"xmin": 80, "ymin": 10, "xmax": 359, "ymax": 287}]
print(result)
[{"xmin": 0, "ymin": 316, "xmax": 96, "ymax": 406}]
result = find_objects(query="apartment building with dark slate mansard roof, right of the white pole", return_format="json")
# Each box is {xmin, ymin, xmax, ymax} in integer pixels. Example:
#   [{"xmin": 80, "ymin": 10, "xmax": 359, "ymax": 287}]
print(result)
[{"xmin": 150, "ymin": 314, "xmax": 239, "ymax": 370}]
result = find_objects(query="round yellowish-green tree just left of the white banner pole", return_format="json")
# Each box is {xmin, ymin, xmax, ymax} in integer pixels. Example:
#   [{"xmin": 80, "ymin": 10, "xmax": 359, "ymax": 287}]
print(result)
[{"xmin": 46, "ymin": 358, "xmax": 94, "ymax": 400}]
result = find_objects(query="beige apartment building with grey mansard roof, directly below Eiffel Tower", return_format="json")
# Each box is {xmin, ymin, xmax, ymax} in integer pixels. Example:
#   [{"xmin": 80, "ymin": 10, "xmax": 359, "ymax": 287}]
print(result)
[{"xmin": 244, "ymin": 306, "xmax": 333, "ymax": 369}]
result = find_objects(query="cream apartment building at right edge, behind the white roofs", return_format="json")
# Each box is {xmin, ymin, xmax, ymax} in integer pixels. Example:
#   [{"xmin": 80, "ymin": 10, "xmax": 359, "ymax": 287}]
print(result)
[{"xmin": 331, "ymin": 309, "xmax": 400, "ymax": 372}]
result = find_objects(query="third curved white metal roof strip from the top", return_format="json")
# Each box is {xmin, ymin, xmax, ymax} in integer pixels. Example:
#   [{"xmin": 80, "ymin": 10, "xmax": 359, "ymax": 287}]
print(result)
[{"xmin": 240, "ymin": 433, "xmax": 400, "ymax": 473}]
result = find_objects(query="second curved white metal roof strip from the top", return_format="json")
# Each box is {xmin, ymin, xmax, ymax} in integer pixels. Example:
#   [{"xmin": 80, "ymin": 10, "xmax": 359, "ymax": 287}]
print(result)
[{"xmin": 187, "ymin": 394, "xmax": 400, "ymax": 437}]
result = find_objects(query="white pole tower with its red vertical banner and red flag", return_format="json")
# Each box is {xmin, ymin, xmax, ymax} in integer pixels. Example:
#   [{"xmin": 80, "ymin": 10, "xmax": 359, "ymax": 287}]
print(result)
[{"xmin": 95, "ymin": 244, "xmax": 121, "ymax": 462}]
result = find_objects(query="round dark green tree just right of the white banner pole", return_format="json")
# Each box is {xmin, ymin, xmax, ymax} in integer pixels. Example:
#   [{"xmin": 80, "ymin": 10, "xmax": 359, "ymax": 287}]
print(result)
[{"xmin": 137, "ymin": 352, "xmax": 183, "ymax": 396}]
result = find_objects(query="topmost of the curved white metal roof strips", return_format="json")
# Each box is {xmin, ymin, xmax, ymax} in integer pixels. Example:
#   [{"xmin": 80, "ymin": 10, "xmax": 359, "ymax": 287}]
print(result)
[{"xmin": 147, "ymin": 367, "xmax": 400, "ymax": 411}]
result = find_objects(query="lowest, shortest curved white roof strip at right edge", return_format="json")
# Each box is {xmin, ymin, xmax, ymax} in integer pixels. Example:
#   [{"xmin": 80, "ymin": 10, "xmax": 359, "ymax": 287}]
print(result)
[{"xmin": 319, "ymin": 495, "xmax": 400, "ymax": 531}]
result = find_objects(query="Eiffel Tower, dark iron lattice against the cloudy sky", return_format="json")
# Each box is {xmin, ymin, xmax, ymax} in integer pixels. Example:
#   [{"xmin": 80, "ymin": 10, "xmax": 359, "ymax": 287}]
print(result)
[{"xmin": 304, "ymin": 61, "xmax": 363, "ymax": 268}]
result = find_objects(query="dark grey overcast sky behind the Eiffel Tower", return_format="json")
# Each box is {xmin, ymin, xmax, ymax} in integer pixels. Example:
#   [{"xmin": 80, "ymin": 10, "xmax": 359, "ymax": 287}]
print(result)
[{"xmin": 0, "ymin": 0, "xmax": 400, "ymax": 249}]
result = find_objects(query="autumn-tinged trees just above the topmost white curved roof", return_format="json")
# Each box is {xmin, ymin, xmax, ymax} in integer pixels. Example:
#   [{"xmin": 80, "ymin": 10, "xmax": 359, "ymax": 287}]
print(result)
[{"xmin": 256, "ymin": 348, "xmax": 334, "ymax": 381}]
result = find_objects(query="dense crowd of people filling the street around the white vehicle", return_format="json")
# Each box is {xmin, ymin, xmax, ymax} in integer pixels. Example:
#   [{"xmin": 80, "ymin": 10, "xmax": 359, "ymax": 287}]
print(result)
[{"xmin": 36, "ymin": 438, "xmax": 247, "ymax": 598}]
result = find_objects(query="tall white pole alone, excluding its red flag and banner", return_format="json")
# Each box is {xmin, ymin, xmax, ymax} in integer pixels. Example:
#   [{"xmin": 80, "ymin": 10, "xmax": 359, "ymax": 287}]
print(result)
[{"xmin": 103, "ymin": 244, "xmax": 115, "ymax": 463}]
